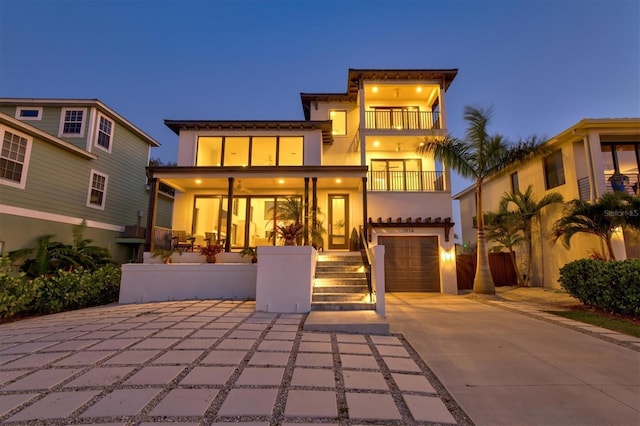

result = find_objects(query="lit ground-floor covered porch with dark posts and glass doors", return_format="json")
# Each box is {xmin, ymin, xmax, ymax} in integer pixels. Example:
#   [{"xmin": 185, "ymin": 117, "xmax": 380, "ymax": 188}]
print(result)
[{"xmin": 145, "ymin": 166, "xmax": 367, "ymax": 252}]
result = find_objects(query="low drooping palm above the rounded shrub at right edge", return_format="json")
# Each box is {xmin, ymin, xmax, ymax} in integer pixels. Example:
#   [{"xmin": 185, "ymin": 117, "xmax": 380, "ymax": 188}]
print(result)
[{"xmin": 554, "ymin": 192, "xmax": 640, "ymax": 260}]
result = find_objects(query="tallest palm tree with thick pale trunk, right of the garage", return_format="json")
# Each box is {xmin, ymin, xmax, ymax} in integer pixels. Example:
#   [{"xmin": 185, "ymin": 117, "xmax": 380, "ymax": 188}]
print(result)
[{"xmin": 418, "ymin": 106, "xmax": 543, "ymax": 294}]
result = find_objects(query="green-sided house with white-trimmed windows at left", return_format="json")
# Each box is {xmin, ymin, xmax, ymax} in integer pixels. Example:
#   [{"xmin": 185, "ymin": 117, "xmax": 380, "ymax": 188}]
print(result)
[{"xmin": 0, "ymin": 98, "xmax": 173, "ymax": 262}]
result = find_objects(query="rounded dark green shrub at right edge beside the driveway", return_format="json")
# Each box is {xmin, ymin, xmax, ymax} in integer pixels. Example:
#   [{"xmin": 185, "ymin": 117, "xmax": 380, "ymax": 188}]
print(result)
[{"xmin": 559, "ymin": 259, "xmax": 640, "ymax": 316}]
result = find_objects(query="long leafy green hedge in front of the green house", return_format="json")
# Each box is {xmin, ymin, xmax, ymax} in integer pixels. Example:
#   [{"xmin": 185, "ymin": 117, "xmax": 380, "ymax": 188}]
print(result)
[{"xmin": 0, "ymin": 258, "xmax": 120, "ymax": 320}]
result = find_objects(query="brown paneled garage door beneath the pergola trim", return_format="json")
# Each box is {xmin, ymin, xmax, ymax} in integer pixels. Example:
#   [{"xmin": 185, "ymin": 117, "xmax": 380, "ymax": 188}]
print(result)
[{"xmin": 378, "ymin": 237, "xmax": 440, "ymax": 292}]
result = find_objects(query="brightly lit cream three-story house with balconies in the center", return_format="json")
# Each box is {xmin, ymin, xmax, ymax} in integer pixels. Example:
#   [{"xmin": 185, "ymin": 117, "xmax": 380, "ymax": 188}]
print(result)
[{"xmin": 148, "ymin": 69, "xmax": 457, "ymax": 292}]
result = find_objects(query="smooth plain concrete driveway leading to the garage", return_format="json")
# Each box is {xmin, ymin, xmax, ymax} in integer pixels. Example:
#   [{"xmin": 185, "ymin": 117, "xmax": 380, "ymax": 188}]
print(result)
[{"xmin": 386, "ymin": 293, "xmax": 640, "ymax": 426}]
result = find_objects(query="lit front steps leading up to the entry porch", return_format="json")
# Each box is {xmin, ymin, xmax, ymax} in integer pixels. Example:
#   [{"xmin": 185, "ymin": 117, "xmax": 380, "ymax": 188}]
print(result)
[{"xmin": 311, "ymin": 252, "xmax": 375, "ymax": 311}]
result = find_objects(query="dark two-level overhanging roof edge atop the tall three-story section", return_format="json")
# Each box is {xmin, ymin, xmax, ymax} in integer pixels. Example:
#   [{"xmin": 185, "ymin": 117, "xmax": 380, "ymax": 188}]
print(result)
[{"xmin": 300, "ymin": 68, "xmax": 458, "ymax": 120}]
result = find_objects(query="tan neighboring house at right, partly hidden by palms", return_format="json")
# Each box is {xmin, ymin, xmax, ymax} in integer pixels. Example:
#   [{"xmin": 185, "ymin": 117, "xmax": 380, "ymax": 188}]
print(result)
[{"xmin": 453, "ymin": 118, "xmax": 640, "ymax": 288}]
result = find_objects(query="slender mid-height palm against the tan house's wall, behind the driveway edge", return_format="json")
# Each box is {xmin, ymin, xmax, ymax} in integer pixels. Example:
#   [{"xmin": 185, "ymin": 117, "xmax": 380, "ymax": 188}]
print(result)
[{"xmin": 500, "ymin": 185, "xmax": 564, "ymax": 286}]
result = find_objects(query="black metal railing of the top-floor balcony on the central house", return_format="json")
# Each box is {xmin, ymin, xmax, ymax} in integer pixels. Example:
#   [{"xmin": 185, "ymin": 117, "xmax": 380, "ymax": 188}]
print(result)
[{"xmin": 365, "ymin": 109, "xmax": 440, "ymax": 130}]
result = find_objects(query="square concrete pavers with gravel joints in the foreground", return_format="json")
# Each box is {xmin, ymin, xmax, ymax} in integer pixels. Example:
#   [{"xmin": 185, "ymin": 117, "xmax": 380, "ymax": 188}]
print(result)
[{"xmin": 0, "ymin": 301, "xmax": 471, "ymax": 426}]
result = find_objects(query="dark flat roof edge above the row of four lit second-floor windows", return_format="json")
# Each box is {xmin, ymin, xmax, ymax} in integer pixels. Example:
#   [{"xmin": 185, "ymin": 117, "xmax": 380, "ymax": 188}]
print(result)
[{"xmin": 164, "ymin": 120, "xmax": 333, "ymax": 144}]
